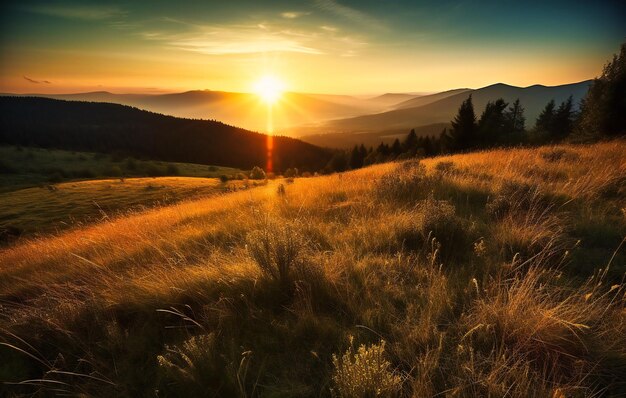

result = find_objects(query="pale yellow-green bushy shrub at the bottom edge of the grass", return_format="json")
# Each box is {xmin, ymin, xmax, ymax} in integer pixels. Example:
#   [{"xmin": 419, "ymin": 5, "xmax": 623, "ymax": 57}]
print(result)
[{"xmin": 332, "ymin": 337, "xmax": 402, "ymax": 398}]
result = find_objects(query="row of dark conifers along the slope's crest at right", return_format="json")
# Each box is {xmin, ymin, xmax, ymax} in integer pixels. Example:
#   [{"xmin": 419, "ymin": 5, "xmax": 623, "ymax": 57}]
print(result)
[{"xmin": 325, "ymin": 43, "xmax": 626, "ymax": 172}]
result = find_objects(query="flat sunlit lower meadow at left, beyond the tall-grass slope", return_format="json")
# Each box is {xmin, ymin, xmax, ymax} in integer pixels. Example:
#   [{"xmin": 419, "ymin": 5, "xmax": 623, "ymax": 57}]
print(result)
[{"xmin": 0, "ymin": 177, "xmax": 234, "ymax": 243}]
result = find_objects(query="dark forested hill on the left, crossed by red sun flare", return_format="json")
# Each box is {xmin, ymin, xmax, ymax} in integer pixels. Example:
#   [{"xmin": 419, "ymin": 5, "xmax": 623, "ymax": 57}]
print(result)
[{"xmin": 0, "ymin": 97, "xmax": 330, "ymax": 171}]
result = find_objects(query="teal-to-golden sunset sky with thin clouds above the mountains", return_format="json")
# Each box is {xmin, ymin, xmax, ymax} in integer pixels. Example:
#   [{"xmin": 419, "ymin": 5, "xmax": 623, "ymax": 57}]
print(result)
[{"xmin": 0, "ymin": 0, "xmax": 626, "ymax": 95}]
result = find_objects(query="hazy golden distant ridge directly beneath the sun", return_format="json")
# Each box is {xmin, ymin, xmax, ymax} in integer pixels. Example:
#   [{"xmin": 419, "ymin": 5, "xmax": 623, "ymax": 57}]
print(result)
[{"xmin": 4, "ymin": 90, "xmax": 389, "ymax": 136}]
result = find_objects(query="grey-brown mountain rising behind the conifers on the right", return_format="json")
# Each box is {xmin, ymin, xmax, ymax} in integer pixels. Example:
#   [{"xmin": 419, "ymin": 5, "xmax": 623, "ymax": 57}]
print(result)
[{"xmin": 310, "ymin": 80, "xmax": 591, "ymax": 135}]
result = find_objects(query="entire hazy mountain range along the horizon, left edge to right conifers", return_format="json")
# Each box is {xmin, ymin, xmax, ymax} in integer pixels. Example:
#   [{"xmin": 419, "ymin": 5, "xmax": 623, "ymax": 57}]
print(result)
[{"xmin": 5, "ymin": 80, "xmax": 591, "ymax": 148}]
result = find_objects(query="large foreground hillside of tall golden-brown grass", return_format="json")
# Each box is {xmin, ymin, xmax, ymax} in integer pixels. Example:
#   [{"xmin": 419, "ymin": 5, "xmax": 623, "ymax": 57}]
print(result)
[{"xmin": 0, "ymin": 141, "xmax": 626, "ymax": 398}]
